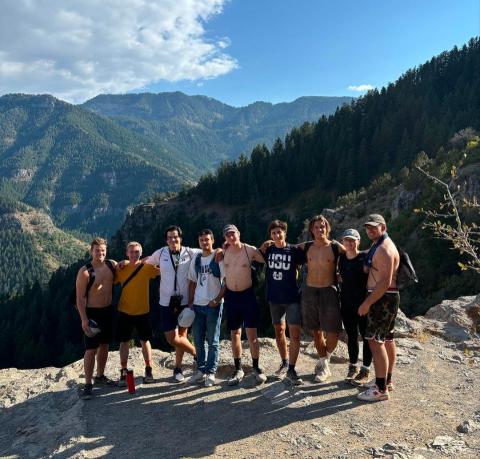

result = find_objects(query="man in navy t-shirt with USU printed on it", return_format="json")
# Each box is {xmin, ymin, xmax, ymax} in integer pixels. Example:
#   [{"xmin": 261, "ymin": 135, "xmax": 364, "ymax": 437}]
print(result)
[{"xmin": 260, "ymin": 220, "xmax": 305, "ymax": 385}]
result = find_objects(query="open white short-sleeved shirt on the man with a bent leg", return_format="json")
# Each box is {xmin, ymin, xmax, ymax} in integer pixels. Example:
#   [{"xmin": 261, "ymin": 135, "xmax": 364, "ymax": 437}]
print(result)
[{"xmin": 147, "ymin": 246, "xmax": 202, "ymax": 306}]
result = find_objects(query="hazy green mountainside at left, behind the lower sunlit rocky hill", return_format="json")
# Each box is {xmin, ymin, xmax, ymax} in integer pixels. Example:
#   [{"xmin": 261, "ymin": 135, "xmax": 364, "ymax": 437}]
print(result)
[{"xmin": 0, "ymin": 95, "xmax": 197, "ymax": 234}]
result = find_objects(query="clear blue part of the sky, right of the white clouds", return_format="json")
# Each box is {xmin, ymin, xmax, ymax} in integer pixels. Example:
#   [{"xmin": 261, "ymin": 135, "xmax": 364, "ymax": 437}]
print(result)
[{"xmin": 147, "ymin": 0, "xmax": 480, "ymax": 106}]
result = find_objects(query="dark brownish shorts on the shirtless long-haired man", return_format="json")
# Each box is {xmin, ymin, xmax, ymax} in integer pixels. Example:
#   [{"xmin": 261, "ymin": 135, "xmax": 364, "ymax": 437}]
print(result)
[{"xmin": 302, "ymin": 285, "xmax": 342, "ymax": 333}]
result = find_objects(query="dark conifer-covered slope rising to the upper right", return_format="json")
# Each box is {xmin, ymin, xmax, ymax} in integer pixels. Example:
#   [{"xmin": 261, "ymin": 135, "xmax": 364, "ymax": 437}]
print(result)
[{"xmin": 192, "ymin": 38, "xmax": 480, "ymax": 207}]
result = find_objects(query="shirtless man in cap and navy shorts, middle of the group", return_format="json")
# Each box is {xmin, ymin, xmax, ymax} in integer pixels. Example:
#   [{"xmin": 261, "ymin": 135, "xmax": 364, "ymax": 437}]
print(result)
[{"xmin": 223, "ymin": 224, "xmax": 267, "ymax": 386}]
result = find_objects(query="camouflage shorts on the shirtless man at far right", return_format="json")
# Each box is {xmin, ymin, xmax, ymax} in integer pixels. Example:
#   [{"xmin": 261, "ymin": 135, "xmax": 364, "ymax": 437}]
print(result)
[{"xmin": 365, "ymin": 293, "xmax": 400, "ymax": 343}]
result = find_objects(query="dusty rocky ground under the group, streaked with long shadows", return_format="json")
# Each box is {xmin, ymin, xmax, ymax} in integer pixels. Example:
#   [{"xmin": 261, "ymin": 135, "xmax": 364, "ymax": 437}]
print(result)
[{"xmin": 0, "ymin": 297, "xmax": 480, "ymax": 459}]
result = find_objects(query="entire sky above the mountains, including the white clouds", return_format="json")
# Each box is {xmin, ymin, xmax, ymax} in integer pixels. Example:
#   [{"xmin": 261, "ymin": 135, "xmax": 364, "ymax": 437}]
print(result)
[{"xmin": 0, "ymin": 0, "xmax": 480, "ymax": 106}]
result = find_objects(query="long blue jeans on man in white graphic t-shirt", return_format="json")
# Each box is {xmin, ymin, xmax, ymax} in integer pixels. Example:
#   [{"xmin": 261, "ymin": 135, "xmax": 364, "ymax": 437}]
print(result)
[{"xmin": 192, "ymin": 303, "xmax": 223, "ymax": 374}]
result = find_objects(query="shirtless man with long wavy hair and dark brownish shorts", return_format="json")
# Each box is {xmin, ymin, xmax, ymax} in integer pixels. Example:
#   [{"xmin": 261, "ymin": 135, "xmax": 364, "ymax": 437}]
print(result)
[{"xmin": 300, "ymin": 215, "xmax": 345, "ymax": 382}]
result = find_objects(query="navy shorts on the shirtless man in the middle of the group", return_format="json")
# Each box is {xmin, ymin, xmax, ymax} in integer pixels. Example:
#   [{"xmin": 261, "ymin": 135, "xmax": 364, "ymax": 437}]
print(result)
[{"xmin": 224, "ymin": 287, "xmax": 259, "ymax": 331}]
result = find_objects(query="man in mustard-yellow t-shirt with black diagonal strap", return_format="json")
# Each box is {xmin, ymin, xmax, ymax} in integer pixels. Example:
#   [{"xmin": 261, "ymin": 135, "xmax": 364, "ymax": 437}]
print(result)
[{"xmin": 115, "ymin": 241, "xmax": 159, "ymax": 386}]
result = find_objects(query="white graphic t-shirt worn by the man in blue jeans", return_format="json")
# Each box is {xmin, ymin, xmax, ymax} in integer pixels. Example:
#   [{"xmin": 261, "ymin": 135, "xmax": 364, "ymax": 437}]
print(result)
[{"xmin": 188, "ymin": 253, "xmax": 225, "ymax": 306}]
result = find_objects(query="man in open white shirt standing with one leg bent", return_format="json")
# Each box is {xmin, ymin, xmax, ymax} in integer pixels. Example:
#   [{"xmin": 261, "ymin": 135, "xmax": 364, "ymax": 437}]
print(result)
[{"xmin": 146, "ymin": 226, "xmax": 200, "ymax": 382}]
